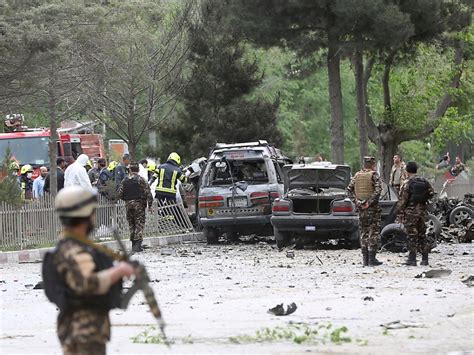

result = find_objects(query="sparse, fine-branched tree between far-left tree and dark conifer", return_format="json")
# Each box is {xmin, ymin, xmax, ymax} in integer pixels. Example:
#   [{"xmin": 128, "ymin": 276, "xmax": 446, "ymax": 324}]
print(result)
[{"xmin": 80, "ymin": 0, "xmax": 194, "ymax": 158}]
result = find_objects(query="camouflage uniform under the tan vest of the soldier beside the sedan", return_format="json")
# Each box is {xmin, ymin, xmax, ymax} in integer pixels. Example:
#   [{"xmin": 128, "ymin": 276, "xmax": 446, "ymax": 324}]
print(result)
[{"xmin": 347, "ymin": 169, "xmax": 382, "ymax": 251}]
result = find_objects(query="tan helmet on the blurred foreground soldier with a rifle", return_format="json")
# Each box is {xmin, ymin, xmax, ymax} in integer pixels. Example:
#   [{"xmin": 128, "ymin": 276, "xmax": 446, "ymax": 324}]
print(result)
[{"xmin": 56, "ymin": 185, "xmax": 97, "ymax": 218}]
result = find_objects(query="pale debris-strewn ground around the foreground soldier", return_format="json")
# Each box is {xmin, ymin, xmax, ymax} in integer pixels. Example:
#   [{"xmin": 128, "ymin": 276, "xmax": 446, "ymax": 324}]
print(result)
[{"xmin": 0, "ymin": 242, "xmax": 474, "ymax": 354}]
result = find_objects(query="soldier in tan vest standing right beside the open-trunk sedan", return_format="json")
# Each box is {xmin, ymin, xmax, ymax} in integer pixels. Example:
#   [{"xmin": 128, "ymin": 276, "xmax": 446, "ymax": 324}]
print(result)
[{"xmin": 347, "ymin": 157, "xmax": 382, "ymax": 266}]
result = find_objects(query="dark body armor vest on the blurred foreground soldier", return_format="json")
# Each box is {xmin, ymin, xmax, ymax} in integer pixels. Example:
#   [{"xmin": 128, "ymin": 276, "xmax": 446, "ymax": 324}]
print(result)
[{"xmin": 42, "ymin": 239, "xmax": 122, "ymax": 313}]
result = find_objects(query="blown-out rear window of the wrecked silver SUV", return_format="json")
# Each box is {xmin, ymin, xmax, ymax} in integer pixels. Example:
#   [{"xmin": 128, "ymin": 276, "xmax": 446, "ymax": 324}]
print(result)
[{"xmin": 204, "ymin": 159, "xmax": 268, "ymax": 186}]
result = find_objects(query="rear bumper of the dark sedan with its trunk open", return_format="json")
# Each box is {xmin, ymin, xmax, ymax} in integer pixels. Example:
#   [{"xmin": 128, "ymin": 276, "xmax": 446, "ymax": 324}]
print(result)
[{"xmin": 271, "ymin": 215, "xmax": 359, "ymax": 233}]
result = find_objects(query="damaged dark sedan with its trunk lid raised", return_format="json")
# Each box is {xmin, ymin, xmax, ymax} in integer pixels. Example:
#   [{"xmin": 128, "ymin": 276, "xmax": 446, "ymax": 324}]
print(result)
[{"xmin": 271, "ymin": 162, "xmax": 359, "ymax": 247}]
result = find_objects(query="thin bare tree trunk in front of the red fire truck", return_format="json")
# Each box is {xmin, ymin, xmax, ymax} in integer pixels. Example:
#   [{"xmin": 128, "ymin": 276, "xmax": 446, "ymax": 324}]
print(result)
[{"xmin": 48, "ymin": 74, "xmax": 59, "ymax": 196}]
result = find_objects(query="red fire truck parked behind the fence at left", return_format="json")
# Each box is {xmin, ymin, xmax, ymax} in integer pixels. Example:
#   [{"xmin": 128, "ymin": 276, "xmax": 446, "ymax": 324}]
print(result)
[{"xmin": 0, "ymin": 114, "xmax": 105, "ymax": 178}]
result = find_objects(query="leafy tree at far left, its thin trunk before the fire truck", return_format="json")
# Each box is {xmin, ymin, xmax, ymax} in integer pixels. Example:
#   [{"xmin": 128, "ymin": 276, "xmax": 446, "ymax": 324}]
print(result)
[{"xmin": 0, "ymin": 0, "xmax": 100, "ymax": 194}]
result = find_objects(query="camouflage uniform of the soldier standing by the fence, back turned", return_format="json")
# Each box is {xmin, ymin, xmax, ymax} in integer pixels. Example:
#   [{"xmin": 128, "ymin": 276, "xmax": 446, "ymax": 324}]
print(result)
[{"xmin": 118, "ymin": 173, "xmax": 153, "ymax": 242}]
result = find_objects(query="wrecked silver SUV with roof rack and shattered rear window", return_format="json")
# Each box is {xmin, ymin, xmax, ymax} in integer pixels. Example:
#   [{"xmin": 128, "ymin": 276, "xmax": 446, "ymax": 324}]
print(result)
[{"xmin": 198, "ymin": 141, "xmax": 291, "ymax": 244}]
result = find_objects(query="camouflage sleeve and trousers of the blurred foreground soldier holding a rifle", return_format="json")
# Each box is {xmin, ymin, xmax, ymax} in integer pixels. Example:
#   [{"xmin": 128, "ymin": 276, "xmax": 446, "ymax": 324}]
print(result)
[{"xmin": 54, "ymin": 239, "xmax": 115, "ymax": 354}]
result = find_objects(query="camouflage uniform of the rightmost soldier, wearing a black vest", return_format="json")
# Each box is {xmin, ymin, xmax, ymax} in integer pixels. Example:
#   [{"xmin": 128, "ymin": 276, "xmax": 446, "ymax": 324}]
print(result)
[{"xmin": 397, "ymin": 175, "xmax": 434, "ymax": 253}]
